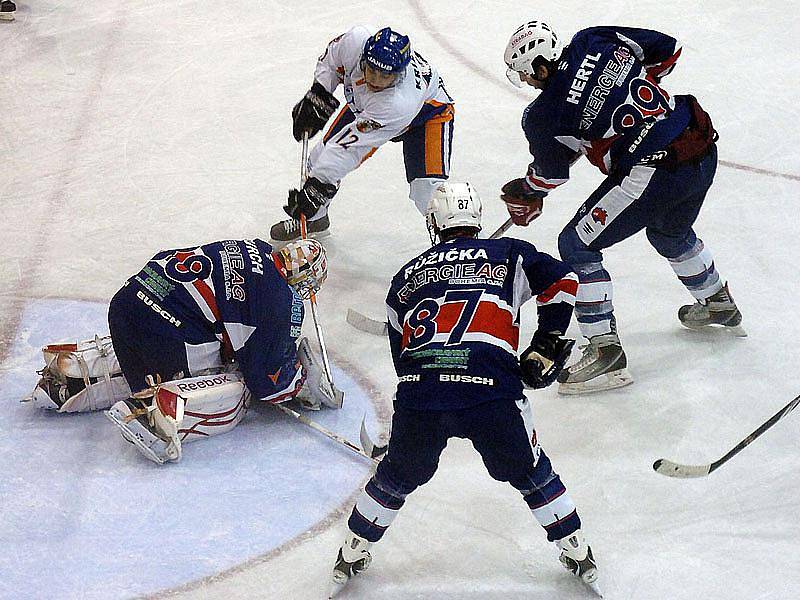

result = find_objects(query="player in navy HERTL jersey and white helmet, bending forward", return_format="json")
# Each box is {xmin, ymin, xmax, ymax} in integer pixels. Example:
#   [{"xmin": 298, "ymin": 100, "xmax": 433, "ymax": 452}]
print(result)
[{"xmin": 501, "ymin": 21, "xmax": 744, "ymax": 393}]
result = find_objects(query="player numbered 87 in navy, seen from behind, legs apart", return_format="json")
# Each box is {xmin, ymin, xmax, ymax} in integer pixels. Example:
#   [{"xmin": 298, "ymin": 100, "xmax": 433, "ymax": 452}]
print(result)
[{"xmin": 333, "ymin": 183, "xmax": 597, "ymax": 593}]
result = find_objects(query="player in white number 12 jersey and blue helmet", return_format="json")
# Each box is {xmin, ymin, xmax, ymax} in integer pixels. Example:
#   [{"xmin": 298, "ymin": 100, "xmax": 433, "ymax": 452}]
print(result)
[{"xmin": 270, "ymin": 25, "xmax": 454, "ymax": 243}]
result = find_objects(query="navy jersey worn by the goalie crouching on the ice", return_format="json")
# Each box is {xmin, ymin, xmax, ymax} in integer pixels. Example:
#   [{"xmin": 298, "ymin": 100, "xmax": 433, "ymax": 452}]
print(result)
[{"xmin": 127, "ymin": 239, "xmax": 303, "ymax": 402}]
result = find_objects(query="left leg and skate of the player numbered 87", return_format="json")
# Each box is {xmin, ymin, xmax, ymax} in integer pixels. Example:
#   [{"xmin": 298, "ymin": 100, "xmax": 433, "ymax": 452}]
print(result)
[{"xmin": 333, "ymin": 407, "xmax": 448, "ymax": 593}]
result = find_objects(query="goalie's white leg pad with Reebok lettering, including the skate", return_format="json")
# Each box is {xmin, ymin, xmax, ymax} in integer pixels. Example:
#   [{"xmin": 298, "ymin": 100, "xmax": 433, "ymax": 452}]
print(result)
[{"xmin": 106, "ymin": 372, "xmax": 250, "ymax": 464}]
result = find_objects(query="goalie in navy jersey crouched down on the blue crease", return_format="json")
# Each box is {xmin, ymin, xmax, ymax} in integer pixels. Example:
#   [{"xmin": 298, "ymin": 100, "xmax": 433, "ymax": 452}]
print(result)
[{"xmin": 21, "ymin": 239, "xmax": 342, "ymax": 464}]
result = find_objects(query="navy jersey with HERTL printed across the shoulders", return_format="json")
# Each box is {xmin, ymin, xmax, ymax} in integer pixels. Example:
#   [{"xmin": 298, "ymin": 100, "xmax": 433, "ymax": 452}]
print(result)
[{"xmin": 522, "ymin": 27, "xmax": 690, "ymax": 195}]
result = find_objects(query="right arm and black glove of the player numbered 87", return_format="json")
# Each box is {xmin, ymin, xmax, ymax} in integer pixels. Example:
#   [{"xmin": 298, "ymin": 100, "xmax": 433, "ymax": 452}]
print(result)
[{"xmin": 515, "ymin": 240, "xmax": 578, "ymax": 389}]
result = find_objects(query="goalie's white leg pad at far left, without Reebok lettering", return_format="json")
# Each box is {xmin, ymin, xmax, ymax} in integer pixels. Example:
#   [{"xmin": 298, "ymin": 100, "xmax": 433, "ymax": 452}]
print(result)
[{"xmin": 26, "ymin": 335, "xmax": 131, "ymax": 412}]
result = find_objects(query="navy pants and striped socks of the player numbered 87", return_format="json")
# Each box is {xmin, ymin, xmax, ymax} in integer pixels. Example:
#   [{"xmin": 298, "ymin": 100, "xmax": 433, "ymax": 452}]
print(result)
[{"xmin": 348, "ymin": 399, "xmax": 581, "ymax": 542}]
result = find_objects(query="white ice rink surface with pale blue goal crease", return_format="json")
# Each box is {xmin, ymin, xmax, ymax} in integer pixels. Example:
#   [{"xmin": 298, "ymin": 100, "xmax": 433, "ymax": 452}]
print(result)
[{"xmin": 0, "ymin": 0, "xmax": 800, "ymax": 600}]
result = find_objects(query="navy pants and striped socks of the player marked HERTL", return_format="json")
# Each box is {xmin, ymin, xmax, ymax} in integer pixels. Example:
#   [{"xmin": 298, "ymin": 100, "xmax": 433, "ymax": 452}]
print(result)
[{"xmin": 558, "ymin": 146, "xmax": 722, "ymax": 338}]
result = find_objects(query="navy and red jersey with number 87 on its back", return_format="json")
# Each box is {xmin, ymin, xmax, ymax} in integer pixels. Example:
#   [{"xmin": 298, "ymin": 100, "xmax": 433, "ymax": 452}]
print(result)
[{"xmin": 386, "ymin": 237, "xmax": 578, "ymax": 410}]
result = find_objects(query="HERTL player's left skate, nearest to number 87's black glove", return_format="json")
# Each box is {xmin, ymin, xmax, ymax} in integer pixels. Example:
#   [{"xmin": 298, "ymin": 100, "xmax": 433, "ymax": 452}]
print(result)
[{"xmin": 558, "ymin": 331, "xmax": 633, "ymax": 395}]
